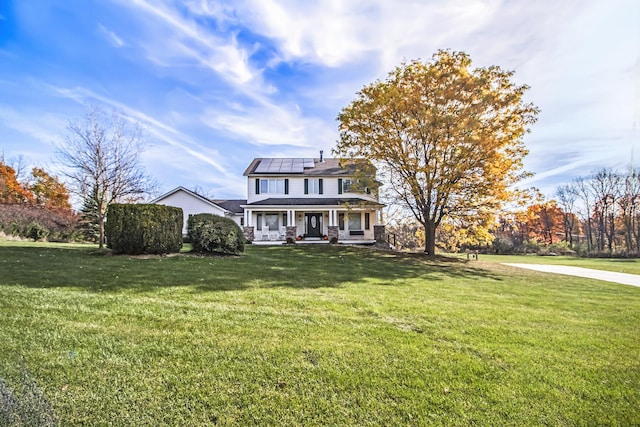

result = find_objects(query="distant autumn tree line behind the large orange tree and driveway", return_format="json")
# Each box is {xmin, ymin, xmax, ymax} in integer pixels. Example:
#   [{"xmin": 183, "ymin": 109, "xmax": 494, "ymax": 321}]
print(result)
[{"xmin": 388, "ymin": 168, "xmax": 640, "ymax": 257}]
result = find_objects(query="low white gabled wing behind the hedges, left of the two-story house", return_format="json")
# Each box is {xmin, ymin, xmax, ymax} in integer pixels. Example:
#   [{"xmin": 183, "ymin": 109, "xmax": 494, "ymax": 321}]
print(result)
[{"xmin": 151, "ymin": 187, "xmax": 247, "ymax": 235}]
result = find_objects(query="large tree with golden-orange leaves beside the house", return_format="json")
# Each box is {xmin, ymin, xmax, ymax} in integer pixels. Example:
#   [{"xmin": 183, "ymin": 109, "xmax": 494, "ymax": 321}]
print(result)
[{"xmin": 335, "ymin": 50, "xmax": 538, "ymax": 255}]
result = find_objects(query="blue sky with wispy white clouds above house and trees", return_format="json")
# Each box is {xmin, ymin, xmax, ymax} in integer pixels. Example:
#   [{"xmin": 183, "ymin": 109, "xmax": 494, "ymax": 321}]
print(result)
[{"xmin": 0, "ymin": 0, "xmax": 640, "ymax": 198}]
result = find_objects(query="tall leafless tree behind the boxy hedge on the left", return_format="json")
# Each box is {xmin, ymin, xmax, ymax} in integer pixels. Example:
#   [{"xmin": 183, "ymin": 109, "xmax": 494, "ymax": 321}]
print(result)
[{"xmin": 56, "ymin": 106, "xmax": 155, "ymax": 248}]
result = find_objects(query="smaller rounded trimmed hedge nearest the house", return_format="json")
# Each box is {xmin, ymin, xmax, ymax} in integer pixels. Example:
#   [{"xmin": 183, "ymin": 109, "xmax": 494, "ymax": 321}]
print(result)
[{"xmin": 187, "ymin": 213, "xmax": 245, "ymax": 255}]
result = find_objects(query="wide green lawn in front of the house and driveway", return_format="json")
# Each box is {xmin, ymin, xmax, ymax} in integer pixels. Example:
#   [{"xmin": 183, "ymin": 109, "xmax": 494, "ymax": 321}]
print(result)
[{"xmin": 0, "ymin": 242, "xmax": 640, "ymax": 426}]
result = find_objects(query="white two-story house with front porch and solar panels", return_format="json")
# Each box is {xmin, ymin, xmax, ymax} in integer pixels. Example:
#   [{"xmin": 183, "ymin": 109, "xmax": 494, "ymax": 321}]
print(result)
[{"xmin": 242, "ymin": 152, "xmax": 384, "ymax": 243}]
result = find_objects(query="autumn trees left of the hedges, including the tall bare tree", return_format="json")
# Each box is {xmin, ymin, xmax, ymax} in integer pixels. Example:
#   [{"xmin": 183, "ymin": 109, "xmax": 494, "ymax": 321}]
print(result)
[{"xmin": 0, "ymin": 106, "xmax": 156, "ymax": 244}]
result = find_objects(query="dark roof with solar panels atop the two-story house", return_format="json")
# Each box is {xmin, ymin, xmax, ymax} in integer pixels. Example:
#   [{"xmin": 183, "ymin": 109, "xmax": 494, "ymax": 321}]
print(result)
[{"xmin": 244, "ymin": 157, "xmax": 375, "ymax": 176}]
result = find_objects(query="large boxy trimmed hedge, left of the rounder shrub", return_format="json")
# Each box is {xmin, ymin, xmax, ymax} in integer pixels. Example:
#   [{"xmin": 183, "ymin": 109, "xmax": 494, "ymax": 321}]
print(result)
[{"xmin": 105, "ymin": 204, "xmax": 183, "ymax": 255}]
